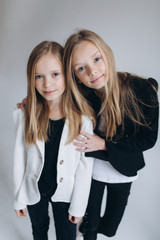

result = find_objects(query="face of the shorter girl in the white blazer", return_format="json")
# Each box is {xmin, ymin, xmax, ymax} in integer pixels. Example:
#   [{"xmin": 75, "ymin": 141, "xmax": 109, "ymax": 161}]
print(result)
[{"xmin": 35, "ymin": 53, "xmax": 65, "ymax": 102}]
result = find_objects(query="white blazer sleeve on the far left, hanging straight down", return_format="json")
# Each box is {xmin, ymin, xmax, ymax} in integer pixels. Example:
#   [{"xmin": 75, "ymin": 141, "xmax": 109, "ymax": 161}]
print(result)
[{"xmin": 13, "ymin": 109, "xmax": 26, "ymax": 210}]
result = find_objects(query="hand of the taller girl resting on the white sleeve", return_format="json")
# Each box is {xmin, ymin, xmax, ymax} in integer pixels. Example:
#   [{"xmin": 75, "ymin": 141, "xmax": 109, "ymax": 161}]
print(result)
[{"xmin": 73, "ymin": 132, "xmax": 107, "ymax": 152}]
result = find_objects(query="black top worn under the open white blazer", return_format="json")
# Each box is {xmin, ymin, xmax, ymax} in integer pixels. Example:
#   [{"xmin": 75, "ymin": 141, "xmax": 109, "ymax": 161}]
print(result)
[{"xmin": 38, "ymin": 119, "xmax": 64, "ymax": 196}]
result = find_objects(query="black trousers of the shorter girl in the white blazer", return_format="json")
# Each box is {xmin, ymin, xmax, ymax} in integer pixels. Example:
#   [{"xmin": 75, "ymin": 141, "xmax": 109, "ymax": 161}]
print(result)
[{"xmin": 27, "ymin": 194, "xmax": 76, "ymax": 240}]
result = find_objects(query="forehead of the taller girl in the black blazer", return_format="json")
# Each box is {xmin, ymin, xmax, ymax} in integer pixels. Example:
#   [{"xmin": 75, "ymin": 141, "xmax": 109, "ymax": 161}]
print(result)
[{"xmin": 72, "ymin": 40, "xmax": 100, "ymax": 64}]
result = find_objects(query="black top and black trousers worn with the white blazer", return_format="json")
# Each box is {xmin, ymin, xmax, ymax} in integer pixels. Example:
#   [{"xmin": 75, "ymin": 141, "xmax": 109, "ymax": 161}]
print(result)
[{"xmin": 27, "ymin": 119, "xmax": 76, "ymax": 240}]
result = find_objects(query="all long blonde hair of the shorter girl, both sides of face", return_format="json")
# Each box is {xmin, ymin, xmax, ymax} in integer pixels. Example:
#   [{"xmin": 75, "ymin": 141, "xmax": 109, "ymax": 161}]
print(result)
[{"xmin": 25, "ymin": 41, "xmax": 94, "ymax": 145}]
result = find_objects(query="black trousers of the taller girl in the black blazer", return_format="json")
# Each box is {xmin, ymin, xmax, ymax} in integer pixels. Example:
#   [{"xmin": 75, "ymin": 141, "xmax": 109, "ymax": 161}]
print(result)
[{"xmin": 80, "ymin": 180, "xmax": 131, "ymax": 240}]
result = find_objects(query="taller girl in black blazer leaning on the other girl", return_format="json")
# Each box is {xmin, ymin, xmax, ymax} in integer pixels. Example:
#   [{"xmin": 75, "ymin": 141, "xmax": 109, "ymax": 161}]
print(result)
[{"xmin": 64, "ymin": 30, "xmax": 159, "ymax": 240}]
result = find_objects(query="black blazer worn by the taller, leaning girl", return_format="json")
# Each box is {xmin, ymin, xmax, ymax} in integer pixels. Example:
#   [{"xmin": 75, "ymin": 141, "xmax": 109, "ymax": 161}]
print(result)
[{"xmin": 86, "ymin": 76, "xmax": 159, "ymax": 176}]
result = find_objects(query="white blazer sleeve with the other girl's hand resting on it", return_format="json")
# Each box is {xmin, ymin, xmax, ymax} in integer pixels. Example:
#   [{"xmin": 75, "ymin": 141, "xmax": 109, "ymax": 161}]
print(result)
[{"xmin": 69, "ymin": 117, "xmax": 93, "ymax": 217}]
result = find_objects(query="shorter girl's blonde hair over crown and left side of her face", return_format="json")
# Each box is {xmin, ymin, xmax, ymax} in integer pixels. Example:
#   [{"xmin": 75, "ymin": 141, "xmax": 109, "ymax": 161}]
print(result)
[{"xmin": 25, "ymin": 41, "xmax": 63, "ymax": 145}]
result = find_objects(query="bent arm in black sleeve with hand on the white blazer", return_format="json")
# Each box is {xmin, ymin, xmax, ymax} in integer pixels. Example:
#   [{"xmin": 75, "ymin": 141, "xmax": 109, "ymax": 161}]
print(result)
[{"xmin": 74, "ymin": 79, "xmax": 159, "ymax": 154}]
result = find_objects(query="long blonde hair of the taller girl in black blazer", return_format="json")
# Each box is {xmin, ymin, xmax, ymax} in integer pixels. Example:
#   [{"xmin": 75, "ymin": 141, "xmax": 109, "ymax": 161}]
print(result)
[{"xmin": 64, "ymin": 29, "xmax": 157, "ymax": 139}]
